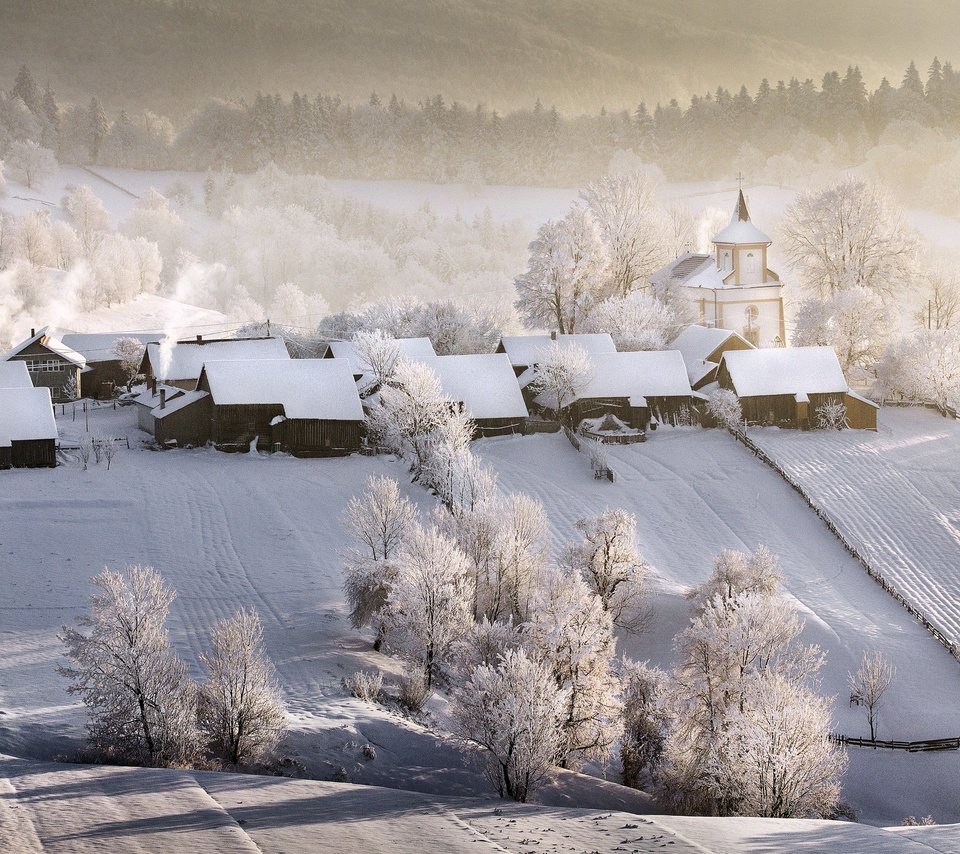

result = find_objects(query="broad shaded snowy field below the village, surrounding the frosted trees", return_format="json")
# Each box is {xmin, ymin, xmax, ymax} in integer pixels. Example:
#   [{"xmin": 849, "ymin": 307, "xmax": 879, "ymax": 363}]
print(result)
[{"xmin": 0, "ymin": 407, "xmax": 960, "ymax": 824}]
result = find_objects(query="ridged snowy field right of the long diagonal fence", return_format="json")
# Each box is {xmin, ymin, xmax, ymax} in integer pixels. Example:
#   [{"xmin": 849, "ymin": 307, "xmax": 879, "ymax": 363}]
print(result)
[{"xmin": 751, "ymin": 408, "xmax": 960, "ymax": 643}]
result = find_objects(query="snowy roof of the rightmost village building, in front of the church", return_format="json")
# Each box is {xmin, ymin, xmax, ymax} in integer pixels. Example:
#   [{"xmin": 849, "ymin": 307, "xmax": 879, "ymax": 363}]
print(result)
[{"xmin": 721, "ymin": 347, "xmax": 847, "ymax": 397}]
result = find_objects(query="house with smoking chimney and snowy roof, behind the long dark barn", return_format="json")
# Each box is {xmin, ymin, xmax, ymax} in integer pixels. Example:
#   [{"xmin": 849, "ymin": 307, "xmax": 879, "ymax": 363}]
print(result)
[{"xmin": 140, "ymin": 335, "xmax": 290, "ymax": 391}]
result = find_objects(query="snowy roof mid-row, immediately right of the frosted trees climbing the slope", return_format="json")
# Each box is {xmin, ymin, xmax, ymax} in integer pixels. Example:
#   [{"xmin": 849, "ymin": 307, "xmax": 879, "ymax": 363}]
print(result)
[{"xmin": 424, "ymin": 353, "xmax": 527, "ymax": 418}]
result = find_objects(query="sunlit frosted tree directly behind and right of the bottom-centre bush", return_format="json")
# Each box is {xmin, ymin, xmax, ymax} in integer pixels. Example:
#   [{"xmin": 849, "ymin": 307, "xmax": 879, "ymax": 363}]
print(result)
[{"xmin": 524, "ymin": 569, "xmax": 623, "ymax": 767}]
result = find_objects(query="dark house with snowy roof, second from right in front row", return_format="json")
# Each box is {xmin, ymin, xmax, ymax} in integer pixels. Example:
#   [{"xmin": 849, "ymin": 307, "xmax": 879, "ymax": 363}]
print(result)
[{"xmin": 535, "ymin": 350, "xmax": 703, "ymax": 429}]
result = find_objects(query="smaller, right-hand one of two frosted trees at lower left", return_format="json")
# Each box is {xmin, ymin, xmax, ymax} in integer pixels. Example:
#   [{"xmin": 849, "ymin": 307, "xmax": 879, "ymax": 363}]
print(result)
[{"xmin": 199, "ymin": 609, "xmax": 287, "ymax": 765}]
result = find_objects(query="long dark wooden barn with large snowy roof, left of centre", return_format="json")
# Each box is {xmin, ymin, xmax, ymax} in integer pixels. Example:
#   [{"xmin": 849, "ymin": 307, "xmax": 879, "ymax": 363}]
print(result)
[{"xmin": 193, "ymin": 359, "xmax": 364, "ymax": 456}]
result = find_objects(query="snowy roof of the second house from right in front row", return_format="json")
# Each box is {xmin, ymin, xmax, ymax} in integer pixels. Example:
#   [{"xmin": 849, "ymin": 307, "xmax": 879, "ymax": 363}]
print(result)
[{"xmin": 537, "ymin": 350, "xmax": 691, "ymax": 406}]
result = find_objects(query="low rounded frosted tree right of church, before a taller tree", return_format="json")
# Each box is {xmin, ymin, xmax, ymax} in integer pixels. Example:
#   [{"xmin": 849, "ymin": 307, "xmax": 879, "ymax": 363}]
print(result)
[{"xmin": 793, "ymin": 285, "xmax": 892, "ymax": 371}]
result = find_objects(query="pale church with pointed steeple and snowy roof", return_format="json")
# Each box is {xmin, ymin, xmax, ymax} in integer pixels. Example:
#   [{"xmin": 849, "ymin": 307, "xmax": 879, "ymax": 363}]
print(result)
[{"xmin": 650, "ymin": 189, "xmax": 787, "ymax": 347}]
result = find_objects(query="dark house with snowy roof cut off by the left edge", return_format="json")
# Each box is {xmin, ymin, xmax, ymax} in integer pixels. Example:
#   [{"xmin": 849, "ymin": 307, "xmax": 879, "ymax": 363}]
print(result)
[{"xmin": 0, "ymin": 386, "xmax": 57, "ymax": 469}]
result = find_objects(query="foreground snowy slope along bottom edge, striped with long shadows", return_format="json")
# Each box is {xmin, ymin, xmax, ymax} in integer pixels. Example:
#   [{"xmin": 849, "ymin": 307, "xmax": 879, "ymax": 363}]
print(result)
[{"xmin": 0, "ymin": 757, "xmax": 960, "ymax": 854}]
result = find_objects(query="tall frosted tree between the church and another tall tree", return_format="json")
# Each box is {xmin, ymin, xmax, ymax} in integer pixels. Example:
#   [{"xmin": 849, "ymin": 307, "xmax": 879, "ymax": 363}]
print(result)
[{"xmin": 580, "ymin": 172, "xmax": 679, "ymax": 298}]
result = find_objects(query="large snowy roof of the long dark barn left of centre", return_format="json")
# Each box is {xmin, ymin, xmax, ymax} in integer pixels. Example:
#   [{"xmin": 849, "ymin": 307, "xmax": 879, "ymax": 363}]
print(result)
[{"xmin": 203, "ymin": 359, "xmax": 363, "ymax": 421}]
